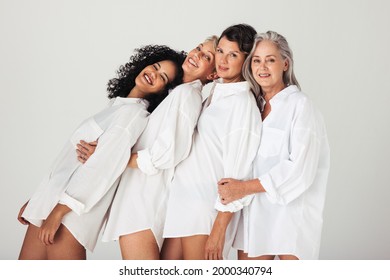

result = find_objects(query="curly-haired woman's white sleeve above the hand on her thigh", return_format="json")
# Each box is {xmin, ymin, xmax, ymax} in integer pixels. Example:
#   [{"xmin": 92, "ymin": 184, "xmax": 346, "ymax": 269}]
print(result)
[{"xmin": 60, "ymin": 118, "xmax": 146, "ymax": 215}]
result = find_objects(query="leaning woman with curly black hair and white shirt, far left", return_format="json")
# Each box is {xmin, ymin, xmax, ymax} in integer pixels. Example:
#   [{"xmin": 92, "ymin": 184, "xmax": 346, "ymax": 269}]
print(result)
[{"xmin": 18, "ymin": 45, "xmax": 185, "ymax": 259}]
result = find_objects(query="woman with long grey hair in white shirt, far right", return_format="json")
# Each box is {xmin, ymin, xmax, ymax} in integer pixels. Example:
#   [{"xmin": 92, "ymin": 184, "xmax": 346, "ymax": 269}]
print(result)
[{"xmin": 218, "ymin": 31, "xmax": 329, "ymax": 260}]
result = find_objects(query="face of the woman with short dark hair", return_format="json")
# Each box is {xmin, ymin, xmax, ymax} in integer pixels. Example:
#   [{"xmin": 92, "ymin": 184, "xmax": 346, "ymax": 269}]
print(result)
[{"xmin": 215, "ymin": 37, "xmax": 246, "ymax": 83}]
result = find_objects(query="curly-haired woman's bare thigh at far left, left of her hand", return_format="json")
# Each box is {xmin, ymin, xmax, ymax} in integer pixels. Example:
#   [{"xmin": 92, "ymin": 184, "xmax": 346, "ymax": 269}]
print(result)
[{"xmin": 19, "ymin": 224, "xmax": 47, "ymax": 260}]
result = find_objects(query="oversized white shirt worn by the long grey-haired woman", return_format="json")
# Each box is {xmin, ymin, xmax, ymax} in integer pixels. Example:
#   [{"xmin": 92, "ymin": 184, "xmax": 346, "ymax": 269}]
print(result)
[{"xmin": 235, "ymin": 86, "xmax": 330, "ymax": 259}]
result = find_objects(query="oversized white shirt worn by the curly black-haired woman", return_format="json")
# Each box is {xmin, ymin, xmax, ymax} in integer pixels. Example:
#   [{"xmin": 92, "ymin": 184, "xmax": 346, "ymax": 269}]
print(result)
[{"xmin": 23, "ymin": 97, "xmax": 149, "ymax": 251}]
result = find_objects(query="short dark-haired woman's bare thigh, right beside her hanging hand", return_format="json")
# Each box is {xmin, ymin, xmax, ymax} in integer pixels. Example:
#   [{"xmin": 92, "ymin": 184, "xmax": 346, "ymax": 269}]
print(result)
[{"xmin": 181, "ymin": 235, "xmax": 209, "ymax": 260}]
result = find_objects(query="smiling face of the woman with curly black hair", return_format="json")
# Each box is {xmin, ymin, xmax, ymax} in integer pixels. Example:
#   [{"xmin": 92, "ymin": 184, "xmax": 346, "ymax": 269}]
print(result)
[{"xmin": 135, "ymin": 60, "xmax": 177, "ymax": 96}]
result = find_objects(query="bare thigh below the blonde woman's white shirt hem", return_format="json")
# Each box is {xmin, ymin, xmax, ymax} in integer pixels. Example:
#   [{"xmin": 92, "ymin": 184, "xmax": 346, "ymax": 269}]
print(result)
[{"xmin": 119, "ymin": 229, "xmax": 160, "ymax": 260}]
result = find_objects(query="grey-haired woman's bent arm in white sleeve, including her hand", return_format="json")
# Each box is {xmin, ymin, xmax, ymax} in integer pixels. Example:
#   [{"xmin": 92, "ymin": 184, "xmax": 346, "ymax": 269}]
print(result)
[{"xmin": 222, "ymin": 99, "xmax": 329, "ymax": 205}]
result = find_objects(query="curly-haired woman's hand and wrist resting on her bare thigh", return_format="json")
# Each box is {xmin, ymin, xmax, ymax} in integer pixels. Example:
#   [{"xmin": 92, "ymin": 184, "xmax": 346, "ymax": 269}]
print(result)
[{"xmin": 38, "ymin": 204, "xmax": 71, "ymax": 245}]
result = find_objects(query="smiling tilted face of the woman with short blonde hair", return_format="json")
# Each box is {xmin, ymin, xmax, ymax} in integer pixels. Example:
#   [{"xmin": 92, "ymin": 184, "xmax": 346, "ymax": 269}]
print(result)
[{"xmin": 182, "ymin": 41, "xmax": 215, "ymax": 84}]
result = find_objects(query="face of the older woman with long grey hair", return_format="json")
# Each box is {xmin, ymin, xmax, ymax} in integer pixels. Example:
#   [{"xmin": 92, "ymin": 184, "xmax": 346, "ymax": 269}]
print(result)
[{"xmin": 251, "ymin": 40, "xmax": 288, "ymax": 94}]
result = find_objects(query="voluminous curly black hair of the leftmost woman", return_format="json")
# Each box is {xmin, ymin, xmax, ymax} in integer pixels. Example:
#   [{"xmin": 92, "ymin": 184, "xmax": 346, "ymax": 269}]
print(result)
[{"xmin": 107, "ymin": 45, "xmax": 186, "ymax": 113}]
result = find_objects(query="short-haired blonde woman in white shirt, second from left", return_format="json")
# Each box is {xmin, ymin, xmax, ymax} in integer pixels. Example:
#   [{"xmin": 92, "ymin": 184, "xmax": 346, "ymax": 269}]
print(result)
[{"xmin": 78, "ymin": 36, "xmax": 221, "ymax": 259}]
